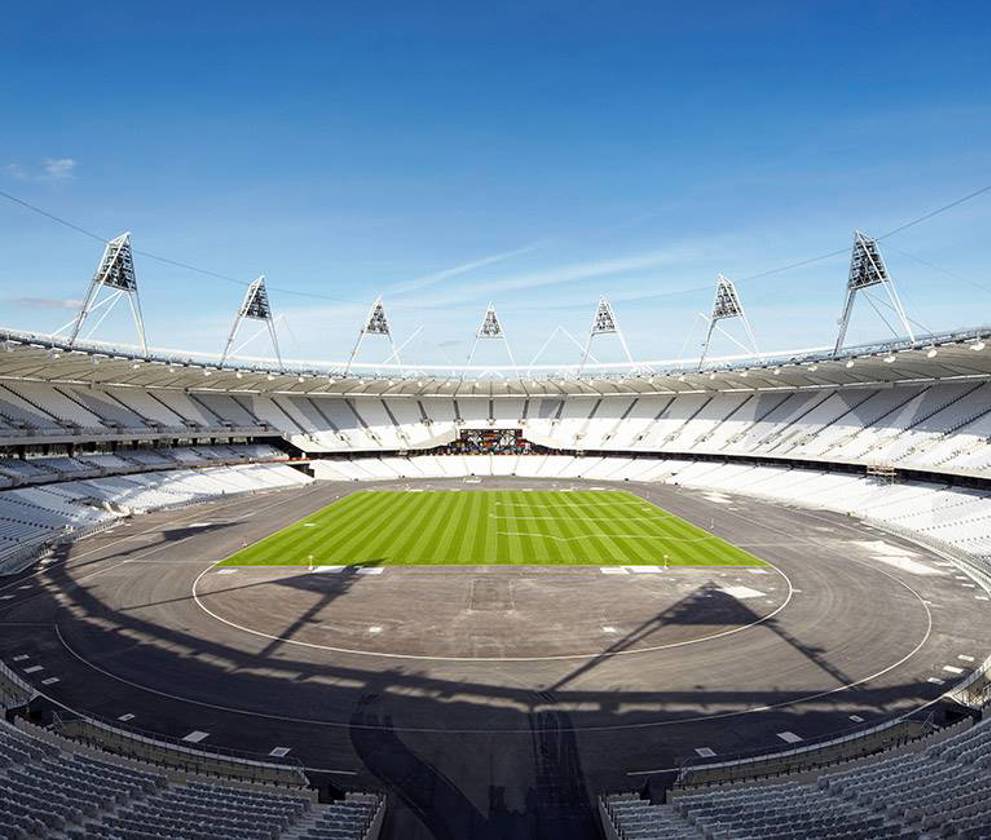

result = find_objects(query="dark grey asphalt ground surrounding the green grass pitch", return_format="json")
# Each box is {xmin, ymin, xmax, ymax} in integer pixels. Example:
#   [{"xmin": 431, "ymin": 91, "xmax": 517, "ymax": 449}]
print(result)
[{"xmin": 0, "ymin": 479, "xmax": 991, "ymax": 840}]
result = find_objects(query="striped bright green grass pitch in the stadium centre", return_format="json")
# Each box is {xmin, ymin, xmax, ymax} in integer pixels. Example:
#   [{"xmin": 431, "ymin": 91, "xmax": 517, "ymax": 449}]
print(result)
[{"xmin": 222, "ymin": 490, "xmax": 764, "ymax": 566}]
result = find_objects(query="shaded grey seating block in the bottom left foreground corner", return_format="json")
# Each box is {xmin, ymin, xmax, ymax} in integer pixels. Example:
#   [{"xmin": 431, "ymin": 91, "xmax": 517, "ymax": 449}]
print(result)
[{"xmin": 0, "ymin": 722, "xmax": 384, "ymax": 840}]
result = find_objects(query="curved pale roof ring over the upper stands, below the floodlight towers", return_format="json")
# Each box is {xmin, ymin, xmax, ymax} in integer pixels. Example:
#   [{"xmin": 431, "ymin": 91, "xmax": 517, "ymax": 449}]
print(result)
[{"xmin": 0, "ymin": 327, "xmax": 991, "ymax": 397}]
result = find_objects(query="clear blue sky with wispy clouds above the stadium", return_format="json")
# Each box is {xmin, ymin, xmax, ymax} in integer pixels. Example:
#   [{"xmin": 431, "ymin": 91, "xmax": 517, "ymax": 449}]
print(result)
[{"xmin": 0, "ymin": 1, "xmax": 991, "ymax": 363}]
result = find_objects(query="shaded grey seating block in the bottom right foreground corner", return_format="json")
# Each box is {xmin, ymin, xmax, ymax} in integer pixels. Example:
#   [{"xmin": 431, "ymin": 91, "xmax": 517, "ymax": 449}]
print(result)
[{"xmin": 600, "ymin": 721, "xmax": 991, "ymax": 840}]
